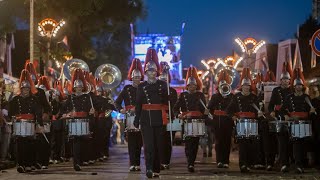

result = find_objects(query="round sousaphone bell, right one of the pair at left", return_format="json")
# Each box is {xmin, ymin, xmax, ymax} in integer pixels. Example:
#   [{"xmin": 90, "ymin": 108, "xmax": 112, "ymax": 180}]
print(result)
[{"xmin": 94, "ymin": 64, "xmax": 121, "ymax": 89}]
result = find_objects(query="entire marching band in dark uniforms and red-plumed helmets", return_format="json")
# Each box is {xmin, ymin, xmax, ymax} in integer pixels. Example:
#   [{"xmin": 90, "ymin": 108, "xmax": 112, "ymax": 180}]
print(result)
[{"xmin": 2, "ymin": 48, "xmax": 320, "ymax": 178}]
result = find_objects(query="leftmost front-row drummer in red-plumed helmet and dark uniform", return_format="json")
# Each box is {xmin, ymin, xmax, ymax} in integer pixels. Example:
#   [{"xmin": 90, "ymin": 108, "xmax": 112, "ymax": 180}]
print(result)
[{"xmin": 9, "ymin": 70, "xmax": 44, "ymax": 173}]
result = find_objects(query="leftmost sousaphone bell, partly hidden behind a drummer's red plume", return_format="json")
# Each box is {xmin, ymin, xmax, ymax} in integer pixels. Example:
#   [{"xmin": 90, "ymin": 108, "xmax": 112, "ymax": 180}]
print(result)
[{"xmin": 63, "ymin": 59, "xmax": 90, "ymax": 81}]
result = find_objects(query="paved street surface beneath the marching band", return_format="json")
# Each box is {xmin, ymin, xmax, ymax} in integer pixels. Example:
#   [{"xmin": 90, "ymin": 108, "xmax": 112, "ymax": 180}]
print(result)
[{"xmin": 0, "ymin": 146, "xmax": 320, "ymax": 180}]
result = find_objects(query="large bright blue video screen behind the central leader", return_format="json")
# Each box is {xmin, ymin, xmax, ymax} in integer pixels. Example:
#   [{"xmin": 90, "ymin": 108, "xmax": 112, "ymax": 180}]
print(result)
[{"xmin": 134, "ymin": 34, "xmax": 182, "ymax": 83}]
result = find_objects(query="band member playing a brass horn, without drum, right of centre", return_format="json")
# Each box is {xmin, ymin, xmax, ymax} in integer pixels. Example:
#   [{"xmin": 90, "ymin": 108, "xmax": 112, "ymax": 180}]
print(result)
[{"xmin": 208, "ymin": 70, "xmax": 234, "ymax": 168}]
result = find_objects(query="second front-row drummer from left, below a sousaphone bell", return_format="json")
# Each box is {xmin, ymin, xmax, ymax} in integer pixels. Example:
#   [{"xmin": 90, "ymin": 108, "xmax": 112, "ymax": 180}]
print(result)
[{"xmin": 62, "ymin": 69, "xmax": 95, "ymax": 171}]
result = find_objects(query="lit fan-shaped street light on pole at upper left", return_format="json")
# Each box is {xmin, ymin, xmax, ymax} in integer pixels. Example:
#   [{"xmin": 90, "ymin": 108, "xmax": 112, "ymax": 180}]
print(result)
[{"xmin": 38, "ymin": 18, "xmax": 66, "ymax": 75}]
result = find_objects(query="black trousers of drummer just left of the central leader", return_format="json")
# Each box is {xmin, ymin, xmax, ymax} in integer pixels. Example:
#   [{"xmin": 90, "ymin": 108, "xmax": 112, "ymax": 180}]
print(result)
[{"xmin": 127, "ymin": 131, "xmax": 143, "ymax": 166}]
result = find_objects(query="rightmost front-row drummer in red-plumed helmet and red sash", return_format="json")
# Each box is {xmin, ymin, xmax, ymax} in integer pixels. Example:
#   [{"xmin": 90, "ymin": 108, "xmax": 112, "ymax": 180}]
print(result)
[{"xmin": 280, "ymin": 68, "xmax": 315, "ymax": 174}]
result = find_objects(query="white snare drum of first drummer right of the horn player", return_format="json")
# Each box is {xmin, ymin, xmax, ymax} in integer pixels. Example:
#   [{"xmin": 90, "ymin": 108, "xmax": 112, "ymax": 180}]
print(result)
[{"xmin": 236, "ymin": 119, "xmax": 258, "ymax": 139}]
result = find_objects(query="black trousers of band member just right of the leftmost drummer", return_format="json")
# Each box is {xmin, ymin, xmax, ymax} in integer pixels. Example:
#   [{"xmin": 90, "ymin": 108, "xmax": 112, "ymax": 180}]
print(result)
[{"xmin": 36, "ymin": 133, "xmax": 51, "ymax": 166}]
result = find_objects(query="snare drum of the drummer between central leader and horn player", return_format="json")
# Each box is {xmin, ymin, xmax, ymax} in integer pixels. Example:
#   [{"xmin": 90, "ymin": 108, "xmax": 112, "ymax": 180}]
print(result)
[{"xmin": 183, "ymin": 119, "xmax": 206, "ymax": 137}]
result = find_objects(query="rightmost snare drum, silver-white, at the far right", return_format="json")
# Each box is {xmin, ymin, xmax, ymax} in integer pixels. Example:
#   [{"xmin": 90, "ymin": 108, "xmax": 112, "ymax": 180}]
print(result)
[{"xmin": 290, "ymin": 121, "xmax": 312, "ymax": 139}]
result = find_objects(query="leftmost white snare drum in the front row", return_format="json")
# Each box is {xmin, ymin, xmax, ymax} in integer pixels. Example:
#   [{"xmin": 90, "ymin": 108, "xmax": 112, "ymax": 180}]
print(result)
[{"xmin": 13, "ymin": 119, "xmax": 36, "ymax": 137}]
